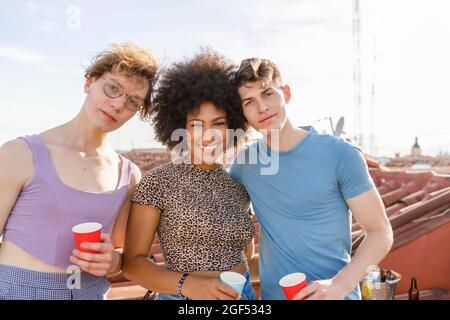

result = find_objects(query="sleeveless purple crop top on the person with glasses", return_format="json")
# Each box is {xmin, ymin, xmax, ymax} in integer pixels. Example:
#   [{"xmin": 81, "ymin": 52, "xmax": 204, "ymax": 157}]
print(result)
[{"xmin": 3, "ymin": 135, "xmax": 131, "ymax": 269}]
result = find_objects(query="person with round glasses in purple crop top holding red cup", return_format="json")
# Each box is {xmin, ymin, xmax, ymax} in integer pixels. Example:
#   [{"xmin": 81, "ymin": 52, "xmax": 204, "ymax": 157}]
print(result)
[{"xmin": 0, "ymin": 43, "xmax": 158, "ymax": 300}]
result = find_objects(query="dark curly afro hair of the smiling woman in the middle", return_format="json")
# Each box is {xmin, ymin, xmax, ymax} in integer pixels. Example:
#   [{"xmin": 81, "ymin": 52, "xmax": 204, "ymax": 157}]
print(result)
[{"xmin": 150, "ymin": 49, "xmax": 248, "ymax": 149}]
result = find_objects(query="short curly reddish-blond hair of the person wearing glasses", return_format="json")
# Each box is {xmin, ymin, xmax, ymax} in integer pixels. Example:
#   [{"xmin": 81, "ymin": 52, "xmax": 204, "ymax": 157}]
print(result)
[{"xmin": 84, "ymin": 43, "xmax": 158, "ymax": 119}]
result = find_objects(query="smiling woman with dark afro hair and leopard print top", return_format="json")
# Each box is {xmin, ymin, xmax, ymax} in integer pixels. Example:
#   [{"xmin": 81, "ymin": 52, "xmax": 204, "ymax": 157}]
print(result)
[{"xmin": 123, "ymin": 50, "xmax": 255, "ymax": 300}]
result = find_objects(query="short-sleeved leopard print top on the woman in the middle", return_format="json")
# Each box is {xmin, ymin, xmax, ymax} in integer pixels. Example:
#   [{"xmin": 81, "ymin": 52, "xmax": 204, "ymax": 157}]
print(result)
[{"xmin": 131, "ymin": 162, "xmax": 255, "ymax": 272}]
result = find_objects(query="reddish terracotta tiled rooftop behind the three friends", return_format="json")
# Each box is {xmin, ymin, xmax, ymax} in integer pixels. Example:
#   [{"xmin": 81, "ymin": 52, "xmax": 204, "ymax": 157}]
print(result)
[{"xmin": 110, "ymin": 149, "xmax": 450, "ymax": 300}]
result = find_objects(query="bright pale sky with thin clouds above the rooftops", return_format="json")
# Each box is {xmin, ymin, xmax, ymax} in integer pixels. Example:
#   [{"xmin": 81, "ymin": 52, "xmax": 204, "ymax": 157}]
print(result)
[{"xmin": 0, "ymin": 0, "xmax": 450, "ymax": 157}]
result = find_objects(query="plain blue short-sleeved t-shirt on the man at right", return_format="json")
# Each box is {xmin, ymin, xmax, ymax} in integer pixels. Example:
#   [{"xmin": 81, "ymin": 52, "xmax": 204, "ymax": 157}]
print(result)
[{"xmin": 230, "ymin": 127, "xmax": 374, "ymax": 300}]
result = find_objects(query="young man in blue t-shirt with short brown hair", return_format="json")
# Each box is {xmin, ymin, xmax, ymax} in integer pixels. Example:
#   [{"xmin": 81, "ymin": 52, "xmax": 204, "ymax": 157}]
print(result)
[{"xmin": 230, "ymin": 58, "xmax": 393, "ymax": 299}]
